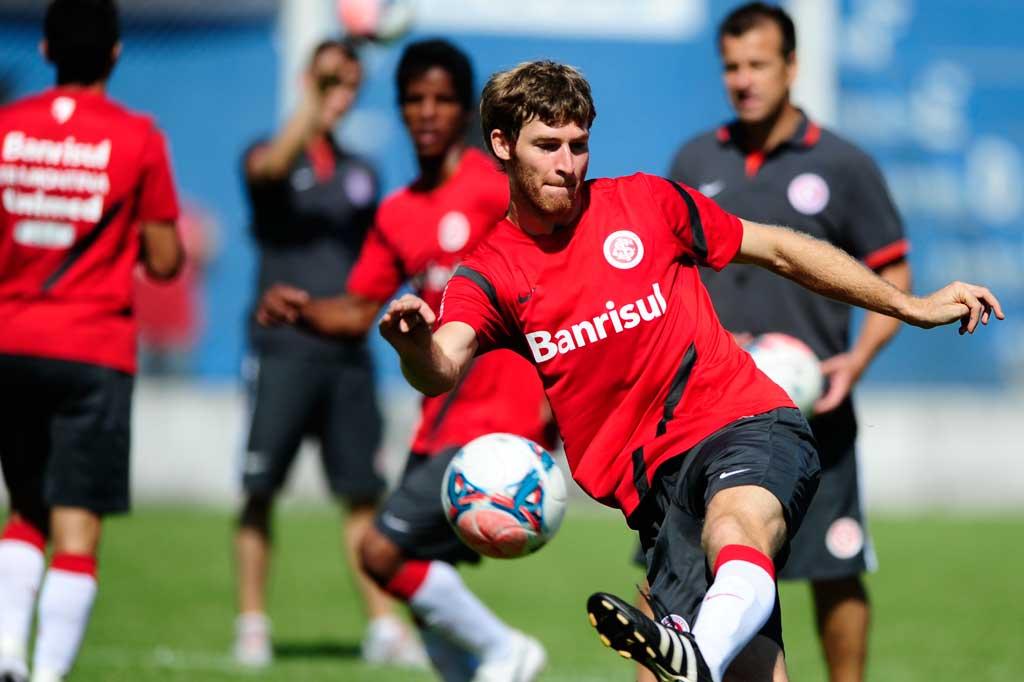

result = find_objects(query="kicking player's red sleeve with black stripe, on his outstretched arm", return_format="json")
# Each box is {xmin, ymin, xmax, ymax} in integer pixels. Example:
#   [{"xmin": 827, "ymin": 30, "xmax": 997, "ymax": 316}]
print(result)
[{"xmin": 647, "ymin": 176, "xmax": 743, "ymax": 270}]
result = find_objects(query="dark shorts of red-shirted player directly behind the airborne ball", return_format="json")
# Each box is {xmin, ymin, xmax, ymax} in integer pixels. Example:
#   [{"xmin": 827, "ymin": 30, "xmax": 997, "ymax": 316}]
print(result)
[{"xmin": 376, "ymin": 447, "xmax": 480, "ymax": 564}]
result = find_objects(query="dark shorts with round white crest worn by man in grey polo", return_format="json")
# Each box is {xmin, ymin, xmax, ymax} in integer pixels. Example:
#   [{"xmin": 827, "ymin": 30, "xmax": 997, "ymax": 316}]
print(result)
[{"xmin": 633, "ymin": 415, "xmax": 876, "ymax": 581}]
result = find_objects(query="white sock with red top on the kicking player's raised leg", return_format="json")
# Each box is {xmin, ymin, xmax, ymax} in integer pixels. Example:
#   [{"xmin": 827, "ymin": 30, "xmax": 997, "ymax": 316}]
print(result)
[{"xmin": 693, "ymin": 545, "xmax": 775, "ymax": 682}]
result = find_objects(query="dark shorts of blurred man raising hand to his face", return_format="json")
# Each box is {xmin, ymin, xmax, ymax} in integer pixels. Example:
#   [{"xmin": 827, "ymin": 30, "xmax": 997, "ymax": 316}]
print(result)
[{"xmin": 242, "ymin": 354, "xmax": 385, "ymax": 504}]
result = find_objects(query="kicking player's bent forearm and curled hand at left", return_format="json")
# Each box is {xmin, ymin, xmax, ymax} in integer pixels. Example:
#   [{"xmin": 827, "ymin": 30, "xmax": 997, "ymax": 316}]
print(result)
[{"xmin": 380, "ymin": 294, "xmax": 477, "ymax": 395}]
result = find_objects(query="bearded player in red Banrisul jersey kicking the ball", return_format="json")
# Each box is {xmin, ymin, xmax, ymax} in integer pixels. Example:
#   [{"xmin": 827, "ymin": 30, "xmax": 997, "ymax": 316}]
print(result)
[{"xmin": 380, "ymin": 61, "xmax": 1002, "ymax": 682}]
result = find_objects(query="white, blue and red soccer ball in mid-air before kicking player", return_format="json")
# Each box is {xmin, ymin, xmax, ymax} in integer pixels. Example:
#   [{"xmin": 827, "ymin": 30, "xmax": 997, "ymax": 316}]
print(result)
[{"xmin": 441, "ymin": 433, "xmax": 566, "ymax": 559}]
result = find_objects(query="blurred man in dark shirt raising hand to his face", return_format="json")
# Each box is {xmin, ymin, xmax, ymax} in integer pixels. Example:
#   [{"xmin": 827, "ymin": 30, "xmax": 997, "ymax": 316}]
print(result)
[{"xmin": 234, "ymin": 35, "xmax": 424, "ymax": 666}]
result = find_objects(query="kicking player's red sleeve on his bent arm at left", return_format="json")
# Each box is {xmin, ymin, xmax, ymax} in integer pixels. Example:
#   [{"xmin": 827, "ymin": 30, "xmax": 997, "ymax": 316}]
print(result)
[{"xmin": 437, "ymin": 264, "xmax": 511, "ymax": 354}]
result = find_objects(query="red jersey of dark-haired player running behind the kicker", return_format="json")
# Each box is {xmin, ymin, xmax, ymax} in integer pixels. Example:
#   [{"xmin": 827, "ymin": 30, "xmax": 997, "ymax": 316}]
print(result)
[{"xmin": 348, "ymin": 148, "xmax": 551, "ymax": 455}]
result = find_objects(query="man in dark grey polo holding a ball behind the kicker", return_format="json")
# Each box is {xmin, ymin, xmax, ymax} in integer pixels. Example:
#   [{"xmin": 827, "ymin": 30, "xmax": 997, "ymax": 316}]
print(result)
[{"xmin": 672, "ymin": 3, "xmax": 910, "ymax": 682}]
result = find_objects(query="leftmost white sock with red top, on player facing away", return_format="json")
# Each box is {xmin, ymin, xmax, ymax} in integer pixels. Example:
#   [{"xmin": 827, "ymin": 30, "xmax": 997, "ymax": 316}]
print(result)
[{"xmin": 0, "ymin": 521, "xmax": 46, "ymax": 664}]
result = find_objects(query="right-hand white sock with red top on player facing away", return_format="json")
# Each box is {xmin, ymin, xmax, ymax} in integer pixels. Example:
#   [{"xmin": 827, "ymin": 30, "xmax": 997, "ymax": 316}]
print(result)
[{"xmin": 32, "ymin": 554, "xmax": 96, "ymax": 679}]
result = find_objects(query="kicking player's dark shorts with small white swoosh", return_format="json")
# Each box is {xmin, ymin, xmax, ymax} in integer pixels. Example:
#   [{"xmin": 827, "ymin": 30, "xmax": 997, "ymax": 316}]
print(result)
[{"xmin": 630, "ymin": 408, "xmax": 820, "ymax": 647}]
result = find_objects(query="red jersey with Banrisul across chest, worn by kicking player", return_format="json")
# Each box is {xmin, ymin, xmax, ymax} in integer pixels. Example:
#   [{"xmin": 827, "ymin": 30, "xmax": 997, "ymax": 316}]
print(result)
[{"xmin": 439, "ymin": 174, "xmax": 793, "ymax": 516}]
